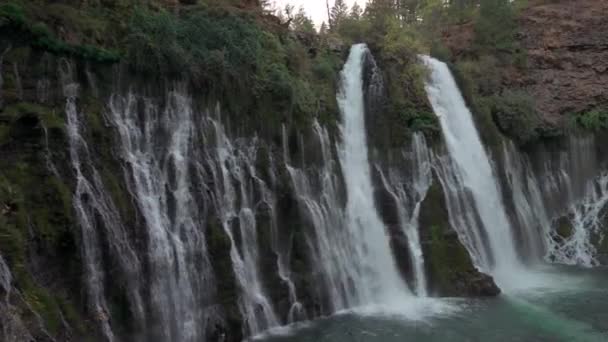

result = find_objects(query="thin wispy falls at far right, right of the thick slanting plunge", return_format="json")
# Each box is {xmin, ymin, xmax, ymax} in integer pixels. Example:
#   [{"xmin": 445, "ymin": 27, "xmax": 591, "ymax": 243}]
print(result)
[{"xmin": 503, "ymin": 136, "xmax": 608, "ymax": 267}]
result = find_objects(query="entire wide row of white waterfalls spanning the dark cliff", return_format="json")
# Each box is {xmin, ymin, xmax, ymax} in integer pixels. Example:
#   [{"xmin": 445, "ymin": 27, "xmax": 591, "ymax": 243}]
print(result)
[{"xmin": 33, "ymin": 44, "xmax": 608, "ymax": 342}]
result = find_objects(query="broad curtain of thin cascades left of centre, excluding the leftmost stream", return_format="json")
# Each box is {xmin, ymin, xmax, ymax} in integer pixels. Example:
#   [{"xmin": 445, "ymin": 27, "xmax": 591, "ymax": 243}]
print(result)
[{"xmin": 110, "ymin": 90, "xmax": 292, "ymax": 342}]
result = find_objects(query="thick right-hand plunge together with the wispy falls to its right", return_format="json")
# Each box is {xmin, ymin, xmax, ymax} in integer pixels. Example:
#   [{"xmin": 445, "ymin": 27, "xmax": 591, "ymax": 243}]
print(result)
[{"xmin": 422, "ymin": 57, "xmax": 608, "ymax": 288}]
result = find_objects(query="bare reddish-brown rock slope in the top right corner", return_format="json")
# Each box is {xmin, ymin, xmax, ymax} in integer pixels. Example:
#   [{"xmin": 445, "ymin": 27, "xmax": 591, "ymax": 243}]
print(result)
[{"xmin": 444, "ymin": 0, "xmax": 608, "ymax": 127}]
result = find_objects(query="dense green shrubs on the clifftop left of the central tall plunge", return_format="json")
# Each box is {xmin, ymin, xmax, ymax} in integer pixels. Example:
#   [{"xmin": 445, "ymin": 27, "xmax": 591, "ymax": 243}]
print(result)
[{"xmin": 127, "ymin": 6, "xmax": 340, "ymax": 132}]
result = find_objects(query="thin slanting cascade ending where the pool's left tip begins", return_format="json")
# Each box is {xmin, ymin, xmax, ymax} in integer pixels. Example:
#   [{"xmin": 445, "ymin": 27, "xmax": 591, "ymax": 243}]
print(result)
[{"xmin": 204, "ymin": 113, "xmax": 279, "ymax": 334}]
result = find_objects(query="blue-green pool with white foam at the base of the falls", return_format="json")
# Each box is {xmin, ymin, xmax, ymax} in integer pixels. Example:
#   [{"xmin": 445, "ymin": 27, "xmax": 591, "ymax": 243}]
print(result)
[{"xmin": 260, "ymin": 266, "xmax": 608, "ymax": 342}]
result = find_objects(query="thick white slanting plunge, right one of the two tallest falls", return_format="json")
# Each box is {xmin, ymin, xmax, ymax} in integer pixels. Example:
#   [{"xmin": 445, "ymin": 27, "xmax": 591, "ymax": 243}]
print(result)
[{"xmin": 423, "ymin": 57, "xmax": 522, "ymax": 281}]
